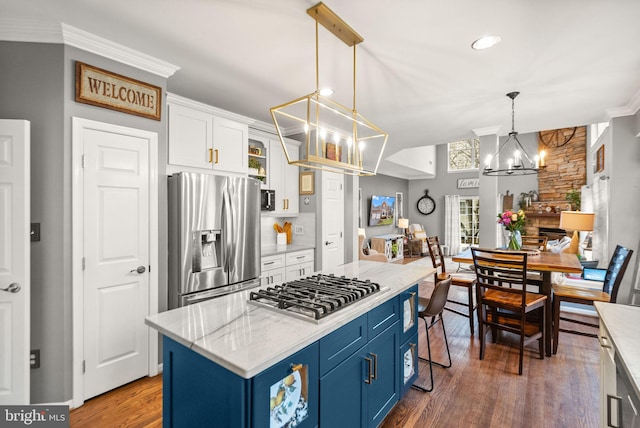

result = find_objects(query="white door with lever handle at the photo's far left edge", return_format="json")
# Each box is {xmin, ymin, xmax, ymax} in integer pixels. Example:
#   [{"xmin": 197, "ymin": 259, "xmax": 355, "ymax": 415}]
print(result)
[{"xmin": 0, "ymin": 120, "xmax": 31, "ymax": 405}]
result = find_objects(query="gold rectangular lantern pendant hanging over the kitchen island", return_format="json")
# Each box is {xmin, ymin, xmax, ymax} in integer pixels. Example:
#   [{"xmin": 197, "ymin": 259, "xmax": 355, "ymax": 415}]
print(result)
[{"xmin": 270, "ymin": 3, "xmax": 389, "ymax": 176}]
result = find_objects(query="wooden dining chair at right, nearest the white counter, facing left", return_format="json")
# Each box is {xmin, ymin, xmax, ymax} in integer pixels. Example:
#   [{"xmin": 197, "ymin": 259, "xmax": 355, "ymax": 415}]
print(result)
[{"xmin": 552, "ymin": 245, "xmax": 633, "ymax": 354}]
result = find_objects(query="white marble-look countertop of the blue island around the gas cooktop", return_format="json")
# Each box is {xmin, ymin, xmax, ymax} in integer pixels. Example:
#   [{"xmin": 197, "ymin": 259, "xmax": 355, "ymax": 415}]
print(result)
[{"xmin": 145, "ymin": 258, "xmax": 434, "ymax": 379}]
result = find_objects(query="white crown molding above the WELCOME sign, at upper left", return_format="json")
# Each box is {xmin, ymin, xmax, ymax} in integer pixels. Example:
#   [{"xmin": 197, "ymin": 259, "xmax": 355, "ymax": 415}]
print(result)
[{"xmin": 0, "ymin": 18, "xmax": 180, "ymax": 78}]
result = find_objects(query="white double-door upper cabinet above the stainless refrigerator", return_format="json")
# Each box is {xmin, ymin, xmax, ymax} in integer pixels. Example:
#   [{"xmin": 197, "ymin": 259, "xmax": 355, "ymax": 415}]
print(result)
[{"xmin": 167, "ymin": 94, "xmax": 249, "ymax": 174}]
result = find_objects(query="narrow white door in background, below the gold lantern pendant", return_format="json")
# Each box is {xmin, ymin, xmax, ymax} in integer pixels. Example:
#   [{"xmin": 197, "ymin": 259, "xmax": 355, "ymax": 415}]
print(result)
[{"xmin": 321, "ymin": 171, "xmax": 344, "ymax": 270}]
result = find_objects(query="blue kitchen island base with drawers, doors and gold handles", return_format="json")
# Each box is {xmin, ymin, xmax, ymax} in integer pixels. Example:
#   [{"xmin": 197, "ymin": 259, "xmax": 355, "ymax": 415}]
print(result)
[{"xmin": 162, "ymin": 286, "xmax": 417, "ymax": 428}]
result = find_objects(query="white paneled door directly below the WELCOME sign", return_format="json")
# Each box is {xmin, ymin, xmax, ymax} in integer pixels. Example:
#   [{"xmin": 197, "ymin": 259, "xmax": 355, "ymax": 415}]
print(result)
[{"xmin": 81, "ymin": 118, "xmax": 155, "ymax": 399}]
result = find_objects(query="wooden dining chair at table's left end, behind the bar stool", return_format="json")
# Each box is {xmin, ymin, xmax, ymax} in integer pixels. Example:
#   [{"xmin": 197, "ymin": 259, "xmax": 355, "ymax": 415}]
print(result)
[{"xmin": 427, "ymin": 236, "xmax": 476, "ymax": 335}]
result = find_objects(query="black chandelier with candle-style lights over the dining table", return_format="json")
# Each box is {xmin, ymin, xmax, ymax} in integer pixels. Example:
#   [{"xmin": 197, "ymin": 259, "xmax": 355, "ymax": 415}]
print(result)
[{"xmin": 482, "ymin": 92, "xmax": 546, "ymax": 176}]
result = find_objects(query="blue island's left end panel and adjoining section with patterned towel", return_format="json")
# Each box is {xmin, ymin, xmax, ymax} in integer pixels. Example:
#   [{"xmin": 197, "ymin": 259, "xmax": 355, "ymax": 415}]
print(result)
[{"xmin": 162, "ymin": 337, "xmax": 318, "ymax": 428}]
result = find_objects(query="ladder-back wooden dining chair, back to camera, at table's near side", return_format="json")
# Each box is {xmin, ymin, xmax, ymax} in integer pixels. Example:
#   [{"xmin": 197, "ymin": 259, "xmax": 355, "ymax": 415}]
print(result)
[{"xmin": 471, "ymin": 248, "xmax": 547, "ymax": 375}]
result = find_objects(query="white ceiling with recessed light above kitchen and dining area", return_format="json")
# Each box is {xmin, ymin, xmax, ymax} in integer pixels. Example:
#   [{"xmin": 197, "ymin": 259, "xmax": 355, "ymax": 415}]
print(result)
[{"xmin": 0, "ymin": 0, "xmax": 640, "ymax": 178}]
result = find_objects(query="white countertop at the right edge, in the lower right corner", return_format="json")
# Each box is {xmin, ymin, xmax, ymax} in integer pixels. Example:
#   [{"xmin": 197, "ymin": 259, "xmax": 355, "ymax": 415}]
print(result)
[{"xmin": 595, "ymin": 302, "xmax": 640, "ymax": 397}]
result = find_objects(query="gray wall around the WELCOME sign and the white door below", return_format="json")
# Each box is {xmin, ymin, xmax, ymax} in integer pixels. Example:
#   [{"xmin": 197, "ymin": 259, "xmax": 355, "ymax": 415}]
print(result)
[{"xmin": 0, "ymin": 42, "xmax": 167, "ymax": 403}]
